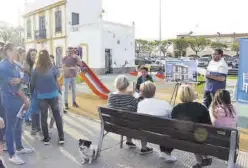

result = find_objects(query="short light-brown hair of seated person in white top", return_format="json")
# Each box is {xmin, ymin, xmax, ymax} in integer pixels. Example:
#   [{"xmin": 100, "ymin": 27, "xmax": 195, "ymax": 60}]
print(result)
[{"xmin": 140, "ymin": 81, "xmax": 156, "ymax": 98}]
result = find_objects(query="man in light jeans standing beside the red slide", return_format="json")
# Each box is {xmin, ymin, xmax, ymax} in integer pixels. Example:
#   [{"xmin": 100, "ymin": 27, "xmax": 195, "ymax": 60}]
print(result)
[{"xmin": 62, "ymin": 47, "xmax": 83, "ymax": 110}]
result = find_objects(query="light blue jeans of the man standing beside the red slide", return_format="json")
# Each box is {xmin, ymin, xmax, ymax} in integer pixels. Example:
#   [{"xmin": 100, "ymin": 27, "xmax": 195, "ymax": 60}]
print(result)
[{"xmin": 64, "ymin": 77, "xmax": 76, "ymax": 103}]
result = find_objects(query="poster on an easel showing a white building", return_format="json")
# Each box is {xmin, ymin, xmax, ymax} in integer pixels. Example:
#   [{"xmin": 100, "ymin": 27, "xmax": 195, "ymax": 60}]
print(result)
[{"xmin": 165, "ymin": 59, "xmax": 197, "ymax": 82}]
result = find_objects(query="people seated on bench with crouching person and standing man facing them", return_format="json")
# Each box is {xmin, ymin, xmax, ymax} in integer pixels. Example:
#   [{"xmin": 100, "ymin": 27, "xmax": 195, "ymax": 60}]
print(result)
[{"xmin": 108, "ymin": 49, "xmax": 238, "ymax": 168}]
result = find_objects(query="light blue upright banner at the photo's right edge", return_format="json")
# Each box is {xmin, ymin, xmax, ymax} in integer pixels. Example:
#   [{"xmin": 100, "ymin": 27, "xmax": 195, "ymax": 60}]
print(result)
[{"xmin": 237, "ymin": 38, "xmax": 248, "ymax": 104}]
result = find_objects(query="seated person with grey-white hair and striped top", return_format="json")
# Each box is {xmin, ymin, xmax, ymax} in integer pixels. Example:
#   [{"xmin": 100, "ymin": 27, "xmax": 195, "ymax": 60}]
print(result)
[{"xmin": 108, "ymin": 75, "xmax": 138, "ymax": 147}]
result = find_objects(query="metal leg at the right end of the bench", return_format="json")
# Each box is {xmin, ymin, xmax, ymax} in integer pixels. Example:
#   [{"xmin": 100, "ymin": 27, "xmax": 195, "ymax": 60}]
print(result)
[{"xmin": 227, "ymin": 131, "xmax": 237, "ymax": 168}]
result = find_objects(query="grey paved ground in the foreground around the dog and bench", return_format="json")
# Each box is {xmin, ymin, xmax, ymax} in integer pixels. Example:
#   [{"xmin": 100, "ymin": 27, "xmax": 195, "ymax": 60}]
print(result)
[{"xmin": 5, "ymin": 114, "xmax": 248, "ymax": 168}]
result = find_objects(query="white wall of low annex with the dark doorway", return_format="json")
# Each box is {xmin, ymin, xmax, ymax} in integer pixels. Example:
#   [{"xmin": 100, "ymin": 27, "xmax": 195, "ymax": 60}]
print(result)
[{"xmin": 102, "ymin": 22, "xmax": 135, "ymax": 68}]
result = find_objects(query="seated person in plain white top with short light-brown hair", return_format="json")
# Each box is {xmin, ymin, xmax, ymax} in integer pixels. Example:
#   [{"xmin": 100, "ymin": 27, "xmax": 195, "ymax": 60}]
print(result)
[{"xmin": 137, "ymin": 81, "xmax": 176, "ymax": 162}]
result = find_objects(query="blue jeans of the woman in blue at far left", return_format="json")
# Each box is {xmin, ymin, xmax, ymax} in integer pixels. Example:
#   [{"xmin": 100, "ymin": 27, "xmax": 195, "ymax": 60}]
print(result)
[{"xmin": 2, "ymin": 96, "xmax": 23, "ymax": 157}]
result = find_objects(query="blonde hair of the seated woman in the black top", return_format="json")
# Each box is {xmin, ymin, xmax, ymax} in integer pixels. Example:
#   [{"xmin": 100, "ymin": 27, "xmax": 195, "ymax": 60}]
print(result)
[{"xmin": 178, "ymin": 84, "xmax": 195, "ymax": 102}]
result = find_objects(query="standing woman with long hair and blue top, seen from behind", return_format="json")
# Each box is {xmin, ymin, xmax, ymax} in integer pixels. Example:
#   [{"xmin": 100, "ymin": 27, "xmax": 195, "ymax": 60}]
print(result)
[{"xmin": 31, "ymin": 50, "xmax": 64, "ymax": 145}]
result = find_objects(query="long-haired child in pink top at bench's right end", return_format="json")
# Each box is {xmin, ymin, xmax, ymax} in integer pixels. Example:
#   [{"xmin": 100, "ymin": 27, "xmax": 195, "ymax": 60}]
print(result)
[{"xmin": 209, "ymin": 89, "xmax": 238, "ymax": 129}]
